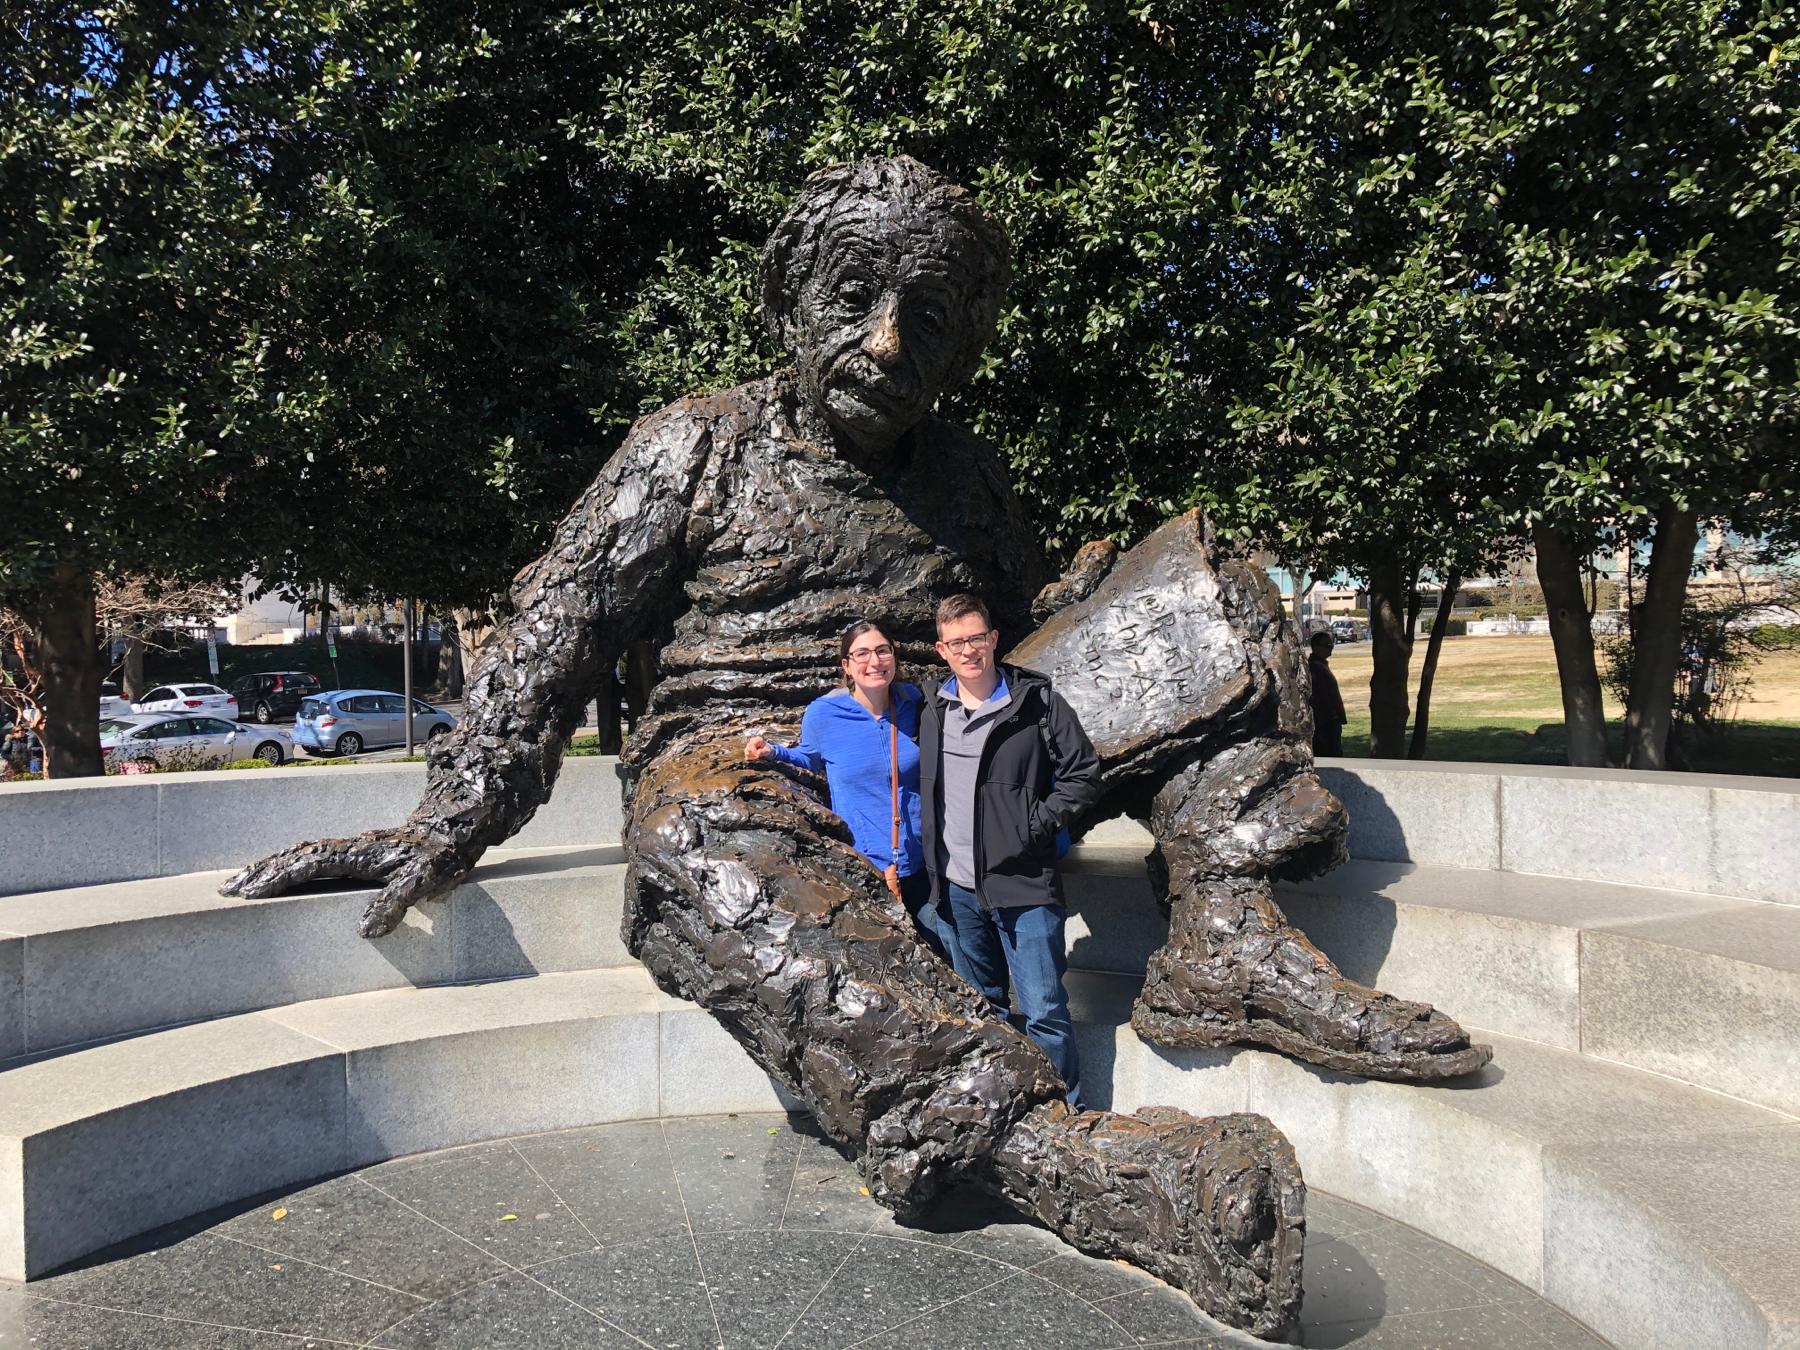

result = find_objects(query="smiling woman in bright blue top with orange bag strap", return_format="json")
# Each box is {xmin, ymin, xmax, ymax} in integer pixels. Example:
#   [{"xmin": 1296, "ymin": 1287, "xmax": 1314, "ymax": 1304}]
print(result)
[{"xmin": 743, "ymin": 619, "xmax": 956, "ymax": 965}]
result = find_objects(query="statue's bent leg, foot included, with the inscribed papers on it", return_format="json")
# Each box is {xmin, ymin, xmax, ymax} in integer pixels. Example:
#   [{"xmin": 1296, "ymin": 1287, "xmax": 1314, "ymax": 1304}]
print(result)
[{"xmin": 1008, "ymin": 515, "xmax": 1492, "ymax": 1080}]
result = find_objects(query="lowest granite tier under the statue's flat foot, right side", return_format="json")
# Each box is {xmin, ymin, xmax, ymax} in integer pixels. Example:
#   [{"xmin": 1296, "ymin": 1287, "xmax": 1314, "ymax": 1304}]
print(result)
[{"xmin": 1069, "ymin": 972, "xmax": 1800, "ymax": 1350}]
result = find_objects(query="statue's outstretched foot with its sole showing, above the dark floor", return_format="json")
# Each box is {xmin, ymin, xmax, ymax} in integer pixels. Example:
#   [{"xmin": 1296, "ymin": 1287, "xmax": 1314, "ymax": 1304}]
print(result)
[{"xmin": 990, "ymin": 1102, "xmax": 1307, "ymax": 1339}]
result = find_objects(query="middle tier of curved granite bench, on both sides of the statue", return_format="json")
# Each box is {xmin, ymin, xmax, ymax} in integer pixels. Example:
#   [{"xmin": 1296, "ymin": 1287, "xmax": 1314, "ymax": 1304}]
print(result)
[{"xmin": 14, "ymin": 846, "xmax": 1800, "ymax": 1112}]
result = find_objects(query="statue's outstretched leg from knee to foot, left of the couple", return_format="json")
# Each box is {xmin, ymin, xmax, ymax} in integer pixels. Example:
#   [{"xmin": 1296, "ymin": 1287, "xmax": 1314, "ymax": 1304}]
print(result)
[{"xmin": 625, "ymin": 734, "xmax": 1305, "ymax": 1336}]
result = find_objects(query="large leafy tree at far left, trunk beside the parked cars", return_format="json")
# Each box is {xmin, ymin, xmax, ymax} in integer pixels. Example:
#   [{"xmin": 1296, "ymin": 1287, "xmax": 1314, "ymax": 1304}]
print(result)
[{"xmin": 0, "ymin": 0, "xmax": 662, "ymax": 776}]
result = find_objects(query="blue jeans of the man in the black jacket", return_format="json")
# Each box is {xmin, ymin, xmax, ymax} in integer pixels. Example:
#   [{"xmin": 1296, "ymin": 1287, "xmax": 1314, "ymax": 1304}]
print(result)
[{"xmin": 943, "ymin": 878, "xmax": 1082, "ymax": 1111}]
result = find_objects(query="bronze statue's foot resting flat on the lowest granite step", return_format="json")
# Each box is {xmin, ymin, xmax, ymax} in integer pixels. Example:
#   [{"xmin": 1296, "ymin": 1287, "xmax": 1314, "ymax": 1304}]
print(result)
[{"xmin": 1132, "ymin": 878, "xmax": 1494, "ymax": 1082}]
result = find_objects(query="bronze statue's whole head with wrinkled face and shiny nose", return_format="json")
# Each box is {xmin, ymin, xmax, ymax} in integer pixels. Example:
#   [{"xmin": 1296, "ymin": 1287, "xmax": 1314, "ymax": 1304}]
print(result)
[{"xmin": 763, "ymin": 155, "xmax": 1010, "ymax": 452}]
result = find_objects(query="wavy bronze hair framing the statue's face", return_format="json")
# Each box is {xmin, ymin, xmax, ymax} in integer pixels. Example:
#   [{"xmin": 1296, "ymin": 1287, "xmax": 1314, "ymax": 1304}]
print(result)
[{"xmin": 761, "ymin": 155, "xmax": 1012, "ymax": 389}]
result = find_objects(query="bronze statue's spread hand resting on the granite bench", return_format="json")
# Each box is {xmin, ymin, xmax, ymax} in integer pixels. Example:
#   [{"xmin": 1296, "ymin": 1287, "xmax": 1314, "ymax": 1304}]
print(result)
[{"xmin": 220, "ymin": 826, "xmax": 468, "ymax": 938}]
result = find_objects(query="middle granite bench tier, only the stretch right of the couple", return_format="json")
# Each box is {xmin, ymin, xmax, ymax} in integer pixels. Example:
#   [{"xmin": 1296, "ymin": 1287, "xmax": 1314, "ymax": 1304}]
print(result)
[{"xmin": 1066, "ymin": 846, "xmax": 1800, "ymax": 1112}]
